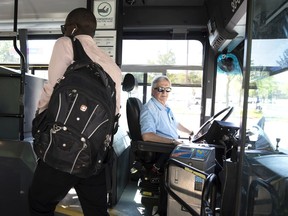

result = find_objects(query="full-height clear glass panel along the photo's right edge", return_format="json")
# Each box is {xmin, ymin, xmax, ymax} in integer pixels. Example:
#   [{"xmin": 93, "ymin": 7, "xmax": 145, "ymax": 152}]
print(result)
[{"xmin": 239, "ymin": 0, "xmax": 288, "ymax": 215}]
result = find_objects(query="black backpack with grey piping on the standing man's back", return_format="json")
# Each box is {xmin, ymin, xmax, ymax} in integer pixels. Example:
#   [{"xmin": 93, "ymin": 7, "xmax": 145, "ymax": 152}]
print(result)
[{"xmin": 32, "ymin": 38, "xmax": 119, "ymax": 177}]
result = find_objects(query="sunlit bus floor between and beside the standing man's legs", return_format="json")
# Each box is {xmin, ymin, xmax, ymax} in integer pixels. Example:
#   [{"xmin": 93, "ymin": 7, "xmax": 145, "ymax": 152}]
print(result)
[{"xmin": 55, "ymin": 181, "xmax": 157, "ymax": 216}]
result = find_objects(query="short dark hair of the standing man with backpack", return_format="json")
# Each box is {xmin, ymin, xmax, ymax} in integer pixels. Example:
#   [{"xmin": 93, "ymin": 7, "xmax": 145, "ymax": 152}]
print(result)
[{"xmin": 66, "ymin": 8, "xmax": 97, "ymax": 37}]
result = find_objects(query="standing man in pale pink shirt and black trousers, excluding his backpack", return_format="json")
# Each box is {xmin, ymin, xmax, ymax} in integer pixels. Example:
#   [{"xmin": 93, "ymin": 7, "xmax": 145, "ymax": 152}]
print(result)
[{"xmin": 29, "ymin": 8, "xmax": 121, "ymax": 216}]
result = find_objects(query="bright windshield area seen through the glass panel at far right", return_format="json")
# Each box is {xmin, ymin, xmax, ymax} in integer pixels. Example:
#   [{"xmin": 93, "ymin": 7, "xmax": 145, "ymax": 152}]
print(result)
[{"xmin": 247, "ymin": 38, "xmax": 288, "ymax": 153}]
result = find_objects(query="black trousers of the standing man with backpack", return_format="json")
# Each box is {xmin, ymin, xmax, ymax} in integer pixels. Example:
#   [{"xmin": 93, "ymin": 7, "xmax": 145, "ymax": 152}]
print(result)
[{"xmin": 29, "ymin": 160, "xmax": 109, "ymax": 216}]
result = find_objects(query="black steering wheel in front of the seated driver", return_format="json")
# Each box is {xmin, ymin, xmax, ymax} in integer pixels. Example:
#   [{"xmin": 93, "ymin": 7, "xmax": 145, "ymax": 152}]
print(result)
[{"xmin": 192, "ymin": 107, "xmax": 233, "ymax": 142}]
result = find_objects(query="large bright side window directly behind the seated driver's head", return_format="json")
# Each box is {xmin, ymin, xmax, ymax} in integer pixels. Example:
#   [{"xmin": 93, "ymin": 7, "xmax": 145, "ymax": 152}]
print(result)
[{"xmin": 122, "ymin": 40, "xmax": 203, "ymax": 133}]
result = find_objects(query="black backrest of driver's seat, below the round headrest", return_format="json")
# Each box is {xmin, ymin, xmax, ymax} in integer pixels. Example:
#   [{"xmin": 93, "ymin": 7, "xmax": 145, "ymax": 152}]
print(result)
[{"xmin": 126, "ymin": 97, "xmax": 143, "ymax": 141}]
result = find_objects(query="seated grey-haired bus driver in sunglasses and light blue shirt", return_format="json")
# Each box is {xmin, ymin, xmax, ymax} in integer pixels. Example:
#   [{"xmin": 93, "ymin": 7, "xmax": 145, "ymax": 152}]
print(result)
[{"xmin": 140, "ymin": 75, "xmax": 193, "ymax": 174}]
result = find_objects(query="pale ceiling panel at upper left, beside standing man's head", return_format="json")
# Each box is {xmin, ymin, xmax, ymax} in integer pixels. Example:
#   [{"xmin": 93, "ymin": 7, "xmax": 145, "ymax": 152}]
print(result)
[{"xmin": 0, "ymin": 0, "xmax": 86, "ymax": 31}]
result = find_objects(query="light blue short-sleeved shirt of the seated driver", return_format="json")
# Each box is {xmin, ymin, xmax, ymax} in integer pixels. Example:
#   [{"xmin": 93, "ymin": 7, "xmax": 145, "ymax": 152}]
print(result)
[{"xmin": 140, "ymin": 97, "xmax": 178, "ymax": 139}]
